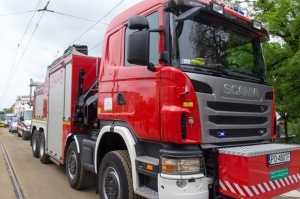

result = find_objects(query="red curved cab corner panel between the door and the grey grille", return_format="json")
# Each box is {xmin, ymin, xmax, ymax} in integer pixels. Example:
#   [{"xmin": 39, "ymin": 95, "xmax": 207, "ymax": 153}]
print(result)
[{"xmin": 160, "ymin": 67, "xmax": 201, "ymax": 144}]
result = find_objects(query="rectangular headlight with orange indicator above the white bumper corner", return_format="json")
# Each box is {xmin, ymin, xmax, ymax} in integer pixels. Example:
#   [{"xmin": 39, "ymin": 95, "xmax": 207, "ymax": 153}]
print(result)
[{"xmin": 161, "ymin": 157, "xmax": 204, "ymax": 175}]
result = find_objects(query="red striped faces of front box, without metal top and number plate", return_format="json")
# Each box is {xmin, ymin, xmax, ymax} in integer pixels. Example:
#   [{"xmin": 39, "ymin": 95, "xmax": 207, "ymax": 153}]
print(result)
[{"xmin": 219, "ymin": 145, "xmax": 300, "ymax": 199}]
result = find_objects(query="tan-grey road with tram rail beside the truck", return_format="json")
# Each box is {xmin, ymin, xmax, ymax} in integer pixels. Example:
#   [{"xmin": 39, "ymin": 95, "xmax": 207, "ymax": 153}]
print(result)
[{"xmin": 0, "ymin": 127, "xmax": 300, "ymax": 199}]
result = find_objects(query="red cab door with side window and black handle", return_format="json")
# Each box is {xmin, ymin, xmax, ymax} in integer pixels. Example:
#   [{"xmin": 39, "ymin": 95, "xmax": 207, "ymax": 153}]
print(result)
[{"xmin": 116, "ymin": 7, "xmax": 161, "ymax": 140}]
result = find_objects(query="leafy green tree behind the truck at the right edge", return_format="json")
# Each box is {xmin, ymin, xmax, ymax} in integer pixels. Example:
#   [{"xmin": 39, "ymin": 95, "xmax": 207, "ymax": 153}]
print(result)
[{"xmin": 248, "ymin": 0, "xmax": 300, "ymax": 142}]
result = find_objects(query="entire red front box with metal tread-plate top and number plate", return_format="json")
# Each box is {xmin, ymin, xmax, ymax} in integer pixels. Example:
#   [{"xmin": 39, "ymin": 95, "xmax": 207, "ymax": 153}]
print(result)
[{"xmin": 219, "ymin": 144, "xmax": 300, "ymax": 199}]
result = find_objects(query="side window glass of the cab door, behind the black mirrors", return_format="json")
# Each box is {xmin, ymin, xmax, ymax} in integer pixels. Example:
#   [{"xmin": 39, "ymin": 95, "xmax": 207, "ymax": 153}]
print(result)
[{"xmin": 124, "ymin": 12, "xmax": 159, "ymax": 66}]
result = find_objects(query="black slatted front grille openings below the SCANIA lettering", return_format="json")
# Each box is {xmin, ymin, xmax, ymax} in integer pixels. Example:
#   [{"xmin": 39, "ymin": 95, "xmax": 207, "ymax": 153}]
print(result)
[{"xmin": 206, "ymin": 101, "xmax": 268, "ymax": 140}]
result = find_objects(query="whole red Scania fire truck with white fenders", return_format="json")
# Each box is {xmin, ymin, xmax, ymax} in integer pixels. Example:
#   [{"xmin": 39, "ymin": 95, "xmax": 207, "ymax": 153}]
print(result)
[{"xmin": 31, "ymin": 0, "xmax": 300, "ymax": 199}]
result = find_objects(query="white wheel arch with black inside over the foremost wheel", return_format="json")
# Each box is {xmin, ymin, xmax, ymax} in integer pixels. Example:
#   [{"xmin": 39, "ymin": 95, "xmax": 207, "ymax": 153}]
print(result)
[{"xmin": 94, "ymin": 126, "xmax": 138, "ymax": 190}]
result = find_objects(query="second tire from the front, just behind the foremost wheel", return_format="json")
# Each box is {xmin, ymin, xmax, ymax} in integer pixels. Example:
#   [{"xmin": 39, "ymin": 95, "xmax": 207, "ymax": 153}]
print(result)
[{"xmin": 66, "ymin": 141, "xmax": 96, "ymax": 190}]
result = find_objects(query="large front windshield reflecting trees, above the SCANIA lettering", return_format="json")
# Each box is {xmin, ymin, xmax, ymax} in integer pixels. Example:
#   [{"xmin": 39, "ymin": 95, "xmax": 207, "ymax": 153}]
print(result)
[{"xmin": 170, "ymin": 13, "xmax": 266, "ymax": 82}]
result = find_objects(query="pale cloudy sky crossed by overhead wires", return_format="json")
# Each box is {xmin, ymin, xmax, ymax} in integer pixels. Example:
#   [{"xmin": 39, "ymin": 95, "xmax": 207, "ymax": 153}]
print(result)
[{"xmin": 0, "ymin": 0, "xmax": 141, "ymax": 110}]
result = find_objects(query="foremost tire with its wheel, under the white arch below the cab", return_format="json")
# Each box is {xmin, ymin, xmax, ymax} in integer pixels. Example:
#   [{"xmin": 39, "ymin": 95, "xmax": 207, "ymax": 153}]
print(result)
[{"xmin": 98, "ymin": 150, "xmax": 138, "ymax": 199}]
